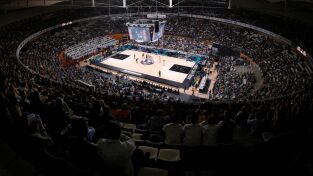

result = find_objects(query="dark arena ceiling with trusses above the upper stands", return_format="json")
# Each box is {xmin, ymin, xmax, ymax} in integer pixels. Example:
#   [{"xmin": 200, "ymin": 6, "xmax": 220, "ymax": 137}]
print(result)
[{"xmin": 0, "ymin": 0, "xmax": 313, "ymax": 25}]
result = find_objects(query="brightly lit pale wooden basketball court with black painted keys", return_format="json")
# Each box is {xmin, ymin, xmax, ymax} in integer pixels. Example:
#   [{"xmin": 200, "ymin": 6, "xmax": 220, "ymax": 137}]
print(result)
[{"xmin": 101, "ymin": 50, "xmax": 196, "ymax": 87}]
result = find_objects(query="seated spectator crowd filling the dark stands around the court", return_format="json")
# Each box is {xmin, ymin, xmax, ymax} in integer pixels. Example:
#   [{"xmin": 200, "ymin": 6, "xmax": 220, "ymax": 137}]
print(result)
[{"xmin": 0, "ymin": 6, "xmax": 313, "ymax": 175}]
